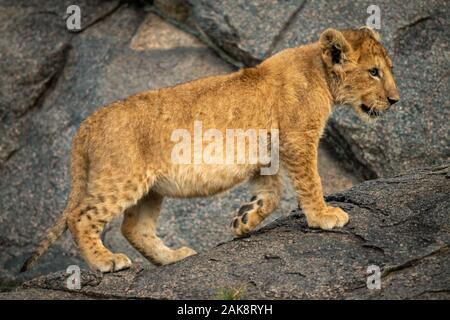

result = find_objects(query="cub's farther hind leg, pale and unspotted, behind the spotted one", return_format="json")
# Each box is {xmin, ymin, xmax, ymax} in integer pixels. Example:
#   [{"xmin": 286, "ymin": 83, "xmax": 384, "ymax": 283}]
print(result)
[{"xmin": 122, "ymin": 192, "xmax": 196, "ymax": 265}]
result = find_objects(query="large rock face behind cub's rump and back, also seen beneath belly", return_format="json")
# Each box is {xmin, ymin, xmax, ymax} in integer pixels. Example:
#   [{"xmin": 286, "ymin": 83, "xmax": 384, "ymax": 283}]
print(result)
[{"xmin": 0, "ymin": 0, "xmax": 358, "ymax": 290}]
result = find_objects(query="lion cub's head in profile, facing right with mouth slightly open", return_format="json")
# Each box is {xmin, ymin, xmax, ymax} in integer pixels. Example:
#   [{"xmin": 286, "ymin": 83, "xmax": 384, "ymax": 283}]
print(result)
[{"xmin": 320, "ymin": 27, "xmax": 400, "ymax": 119}]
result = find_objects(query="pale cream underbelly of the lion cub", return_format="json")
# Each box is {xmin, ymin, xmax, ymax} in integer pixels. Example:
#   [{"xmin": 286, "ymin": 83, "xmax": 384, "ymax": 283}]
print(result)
[{"xmin": 152, "ymin": 165, "xmax": 256, "ymax": 198}]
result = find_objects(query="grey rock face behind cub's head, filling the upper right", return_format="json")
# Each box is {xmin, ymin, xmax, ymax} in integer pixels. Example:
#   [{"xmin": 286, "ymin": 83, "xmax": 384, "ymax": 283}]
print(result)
[{"xmin": 155, "ymin": 0, "xmax": 450, "ymax": 178}]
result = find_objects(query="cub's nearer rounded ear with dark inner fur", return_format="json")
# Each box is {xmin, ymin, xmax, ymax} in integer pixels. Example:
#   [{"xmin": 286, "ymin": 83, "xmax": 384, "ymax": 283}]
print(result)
[{"xmin": 319, "ymin": 28, "xmax": 352, "ymax": 69}]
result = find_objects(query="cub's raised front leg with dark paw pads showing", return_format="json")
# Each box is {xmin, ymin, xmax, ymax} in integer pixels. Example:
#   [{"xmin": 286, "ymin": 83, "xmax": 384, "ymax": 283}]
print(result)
[{"xmin": 230, "ymin": 174, "xmax": 282, "ymax": 237}]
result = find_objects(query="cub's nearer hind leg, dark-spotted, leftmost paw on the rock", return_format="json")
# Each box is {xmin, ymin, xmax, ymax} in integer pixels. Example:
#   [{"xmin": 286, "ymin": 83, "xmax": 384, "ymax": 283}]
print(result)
[{"xmin": 68, "ymin": 171, "xmax": 155, "ymax": 272}]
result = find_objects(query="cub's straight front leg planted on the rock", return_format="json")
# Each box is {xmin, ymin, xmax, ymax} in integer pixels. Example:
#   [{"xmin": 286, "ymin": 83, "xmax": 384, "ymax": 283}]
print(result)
[{"xmin": 281, "ymin": 136, "xmax": 349, "ymax": 230}]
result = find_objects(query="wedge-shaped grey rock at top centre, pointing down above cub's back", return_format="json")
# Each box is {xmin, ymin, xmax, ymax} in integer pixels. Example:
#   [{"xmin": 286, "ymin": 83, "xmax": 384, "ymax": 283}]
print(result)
[{"xmin": 154, "ymin": 0, "xmax": 305, "ymax": 66}]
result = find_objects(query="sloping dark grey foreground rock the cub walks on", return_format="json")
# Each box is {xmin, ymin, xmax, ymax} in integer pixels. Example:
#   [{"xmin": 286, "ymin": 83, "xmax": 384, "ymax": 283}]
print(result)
[{"xmin": 0, "ymin": 162, "xmax": 450, "ymax": 299}]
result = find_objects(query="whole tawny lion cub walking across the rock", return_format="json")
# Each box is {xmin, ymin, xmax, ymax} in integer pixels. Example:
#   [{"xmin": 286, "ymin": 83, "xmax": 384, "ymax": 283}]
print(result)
[{"xmin": 23, "ymin": 27, "xmax": 399, "ymax": 272}]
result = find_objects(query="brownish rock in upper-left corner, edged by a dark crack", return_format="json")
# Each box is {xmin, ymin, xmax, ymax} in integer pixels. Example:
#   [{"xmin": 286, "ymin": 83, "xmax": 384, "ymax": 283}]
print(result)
[{"xmin": 0, "ymin": 0, "xmax": 122, "ymax": 168}]
